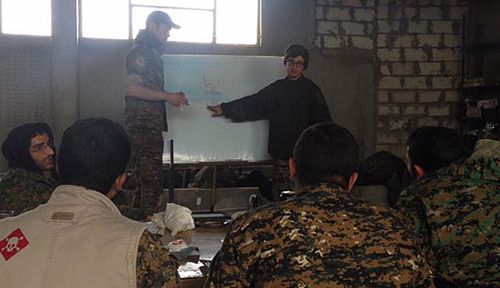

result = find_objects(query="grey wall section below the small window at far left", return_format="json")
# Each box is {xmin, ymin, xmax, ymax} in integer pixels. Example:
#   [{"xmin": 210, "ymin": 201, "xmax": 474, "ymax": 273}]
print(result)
[{"xmin": 0, "ymin": 36, "xmax": 53, "ymax": 171}]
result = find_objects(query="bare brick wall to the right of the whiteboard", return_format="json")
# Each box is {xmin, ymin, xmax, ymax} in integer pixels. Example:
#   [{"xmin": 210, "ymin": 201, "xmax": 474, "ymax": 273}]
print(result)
[{"xmin": 315, "ymin": 0, "xmax": 468, "ymax": 156}]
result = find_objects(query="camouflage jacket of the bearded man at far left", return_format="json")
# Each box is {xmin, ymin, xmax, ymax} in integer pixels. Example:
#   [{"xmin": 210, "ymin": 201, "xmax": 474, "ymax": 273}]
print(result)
[{"xmin": 0, "ymin": 168, "xmax": 58, "ymax": 215}]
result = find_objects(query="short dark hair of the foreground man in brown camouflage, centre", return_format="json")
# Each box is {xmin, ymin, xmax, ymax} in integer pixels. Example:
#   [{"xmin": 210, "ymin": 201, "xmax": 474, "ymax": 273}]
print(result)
[{"xmin": 293, "ymin": 122, "xmax": 359, "ymax": 188}]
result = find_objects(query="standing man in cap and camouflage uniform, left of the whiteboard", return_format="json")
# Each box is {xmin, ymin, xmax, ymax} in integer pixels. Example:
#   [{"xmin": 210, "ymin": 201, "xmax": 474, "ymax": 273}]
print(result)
[{"xmin": 124, "ymin": 11, "xmax": 188, "ymax": 213}]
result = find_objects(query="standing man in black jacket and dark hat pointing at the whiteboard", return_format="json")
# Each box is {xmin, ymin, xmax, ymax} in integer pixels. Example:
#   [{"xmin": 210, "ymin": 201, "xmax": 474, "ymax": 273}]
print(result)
[{"xmin": 207, "ymin": 44, "xmax": 332, "ymax": 198}]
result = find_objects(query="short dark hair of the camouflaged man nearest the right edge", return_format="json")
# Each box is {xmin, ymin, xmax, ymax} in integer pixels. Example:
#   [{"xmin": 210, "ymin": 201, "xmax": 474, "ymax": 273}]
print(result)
[{"xmin": 407, "ymin": 126, "xmax": 465, "ymax": 173}]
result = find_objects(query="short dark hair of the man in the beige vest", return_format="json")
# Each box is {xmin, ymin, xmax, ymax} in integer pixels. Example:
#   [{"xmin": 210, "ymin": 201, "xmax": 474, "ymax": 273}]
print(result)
[{"xmin": 58, "ymin": 118, "xmax": 130, "ymax": 194}]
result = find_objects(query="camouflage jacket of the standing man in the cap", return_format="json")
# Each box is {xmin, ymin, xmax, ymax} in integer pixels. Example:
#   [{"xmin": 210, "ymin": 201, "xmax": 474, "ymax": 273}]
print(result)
[{"xmin": 124, "ymin": 30, "xmax": 167, "ymax": 131}]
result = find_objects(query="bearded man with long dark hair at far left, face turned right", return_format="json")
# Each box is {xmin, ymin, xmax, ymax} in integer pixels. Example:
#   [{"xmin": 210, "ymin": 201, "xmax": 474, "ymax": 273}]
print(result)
[{"xmin": 0, "ymin": 122, "xmax": 57, "ymax": 215}]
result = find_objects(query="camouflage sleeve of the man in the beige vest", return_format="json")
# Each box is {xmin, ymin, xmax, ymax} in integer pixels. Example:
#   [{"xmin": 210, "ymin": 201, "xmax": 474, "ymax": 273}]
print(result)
[{"xmin": 136, "ymin": 231, "xmax": 180, "ymax": 288}]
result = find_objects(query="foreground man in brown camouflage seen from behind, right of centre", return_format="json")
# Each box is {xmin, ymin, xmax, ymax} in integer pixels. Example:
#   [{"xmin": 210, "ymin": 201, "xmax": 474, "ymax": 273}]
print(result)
[{"xmin": 209, "ymin": 123, "xmax": 434, "ymax": 287}]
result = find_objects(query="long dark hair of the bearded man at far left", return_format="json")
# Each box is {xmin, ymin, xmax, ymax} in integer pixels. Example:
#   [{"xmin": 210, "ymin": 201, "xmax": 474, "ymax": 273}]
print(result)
[{"xmin": 2, "ymin": 122, "xmax": 55, "ymax": 173}]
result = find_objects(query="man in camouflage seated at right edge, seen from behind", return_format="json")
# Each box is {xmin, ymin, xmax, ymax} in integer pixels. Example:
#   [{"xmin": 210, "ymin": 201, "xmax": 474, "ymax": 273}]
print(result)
[{"xmin": 396, "ymin": 127, "xmax": 500, "ymax": 287}]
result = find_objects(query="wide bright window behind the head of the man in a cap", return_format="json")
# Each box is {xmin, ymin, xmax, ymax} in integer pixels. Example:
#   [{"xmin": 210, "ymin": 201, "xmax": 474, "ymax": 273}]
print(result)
[{"xmin": 81, "ymin": 0, "xmax": 260, "ymax": 45}]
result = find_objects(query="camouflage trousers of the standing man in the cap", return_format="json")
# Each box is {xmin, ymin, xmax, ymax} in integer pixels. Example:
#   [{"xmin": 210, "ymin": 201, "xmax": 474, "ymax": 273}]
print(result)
[{"xmin": 127, "ymin": 127, "xmax": 163, "ymax": 211}]
